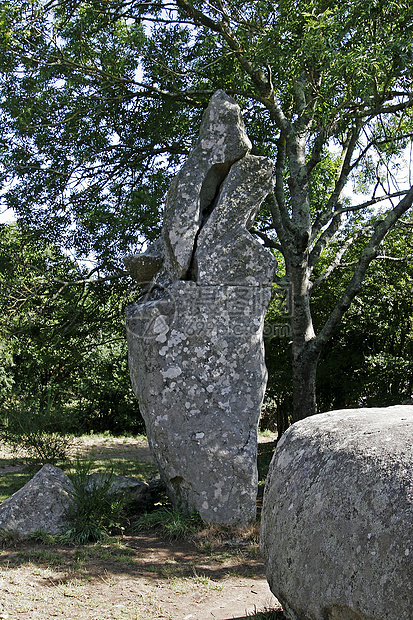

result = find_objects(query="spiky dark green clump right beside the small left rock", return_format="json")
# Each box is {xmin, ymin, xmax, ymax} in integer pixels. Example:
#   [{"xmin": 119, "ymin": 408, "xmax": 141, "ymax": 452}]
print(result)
[{"xmin": 60, "ymin": 458, "xmax": 127, "ymax": 544}]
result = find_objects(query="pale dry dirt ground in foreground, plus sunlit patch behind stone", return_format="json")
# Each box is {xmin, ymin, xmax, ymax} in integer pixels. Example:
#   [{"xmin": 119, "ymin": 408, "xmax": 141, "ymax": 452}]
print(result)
[{"xmin": 0, "ymin": 437, "xmax": 284, "ymax": 620}]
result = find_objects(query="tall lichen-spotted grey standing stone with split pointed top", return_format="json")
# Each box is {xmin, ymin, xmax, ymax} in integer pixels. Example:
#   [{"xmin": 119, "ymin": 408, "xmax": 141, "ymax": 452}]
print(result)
[{"xmin": 125, "ymin": 91, "xmax": 275, "ymax": 525}]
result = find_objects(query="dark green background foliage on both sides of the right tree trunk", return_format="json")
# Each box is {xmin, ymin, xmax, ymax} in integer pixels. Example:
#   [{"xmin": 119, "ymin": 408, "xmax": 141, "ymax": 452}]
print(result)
[{"xmin": 262, "ymin": 217, "xmax": 413, "ymax": 432}]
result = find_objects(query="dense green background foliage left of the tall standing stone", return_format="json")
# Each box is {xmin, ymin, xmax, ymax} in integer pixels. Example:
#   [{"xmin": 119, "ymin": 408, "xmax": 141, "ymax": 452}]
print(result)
[{"xmin": 0, "ymin": 224, "xmax": 143, "ymax": 433}]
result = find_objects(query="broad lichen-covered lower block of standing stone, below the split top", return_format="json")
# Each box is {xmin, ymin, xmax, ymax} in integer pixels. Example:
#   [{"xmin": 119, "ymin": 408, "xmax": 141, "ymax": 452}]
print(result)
[{"xmin": 127, "ymin": 281, "xmax": 270, "ymax": 525}]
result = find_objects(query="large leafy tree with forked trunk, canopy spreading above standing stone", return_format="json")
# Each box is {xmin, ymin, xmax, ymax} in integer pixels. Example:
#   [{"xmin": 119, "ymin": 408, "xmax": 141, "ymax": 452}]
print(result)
[{"xmin": 0, "ymin": 0, "xmax": 413, "ymax": 420}]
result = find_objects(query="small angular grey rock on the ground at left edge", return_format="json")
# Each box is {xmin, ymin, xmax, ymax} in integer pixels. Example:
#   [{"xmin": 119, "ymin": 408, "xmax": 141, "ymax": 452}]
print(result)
[{"xmin": 0, "ymin": 464, "xmax": 73, "ymax": 536}]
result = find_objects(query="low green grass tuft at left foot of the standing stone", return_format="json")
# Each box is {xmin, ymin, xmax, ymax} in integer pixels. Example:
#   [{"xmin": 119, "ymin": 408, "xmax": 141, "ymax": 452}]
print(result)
[{"xmin": 133, "ymin": 506, "xmax": 202, "ymax": 540}]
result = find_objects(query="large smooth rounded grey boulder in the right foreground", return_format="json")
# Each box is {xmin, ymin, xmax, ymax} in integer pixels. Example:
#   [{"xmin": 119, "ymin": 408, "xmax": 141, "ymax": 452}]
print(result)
[{"xmin": 261, "ymin": 406, "xmax": 413, "ymax": 620}]
